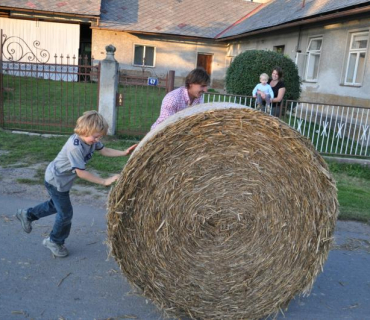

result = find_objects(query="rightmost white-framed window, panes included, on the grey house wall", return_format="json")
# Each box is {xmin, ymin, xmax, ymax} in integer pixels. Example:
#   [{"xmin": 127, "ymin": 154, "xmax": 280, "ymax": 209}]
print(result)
[{"xmin": 344, "ymin": 32, "xmax": 369, "ymax": 85}]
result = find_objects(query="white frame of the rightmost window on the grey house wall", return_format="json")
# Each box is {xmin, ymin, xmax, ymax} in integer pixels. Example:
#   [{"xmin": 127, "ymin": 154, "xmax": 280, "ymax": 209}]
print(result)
[{"xmin": 343, "ymin": 30, "xmax": 370, "ymax": 87}]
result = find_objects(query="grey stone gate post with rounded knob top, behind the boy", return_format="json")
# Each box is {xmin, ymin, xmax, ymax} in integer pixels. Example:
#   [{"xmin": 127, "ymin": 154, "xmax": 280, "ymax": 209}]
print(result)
[{"xmin": 99, "ymin": 45, "xmax": 119, "ymax": 135}]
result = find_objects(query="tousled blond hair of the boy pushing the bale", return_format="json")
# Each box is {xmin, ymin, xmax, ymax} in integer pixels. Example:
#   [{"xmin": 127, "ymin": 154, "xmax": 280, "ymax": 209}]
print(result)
[{"xmin": 74, "ymin": 110, "xmax": 109, "ymax": 136}]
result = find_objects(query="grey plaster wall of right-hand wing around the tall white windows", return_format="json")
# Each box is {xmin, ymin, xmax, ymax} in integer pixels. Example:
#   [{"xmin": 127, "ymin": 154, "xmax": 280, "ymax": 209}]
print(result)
[{"xmin": 227, "ymin": 16, "xmax": 370, "ymax": 107}]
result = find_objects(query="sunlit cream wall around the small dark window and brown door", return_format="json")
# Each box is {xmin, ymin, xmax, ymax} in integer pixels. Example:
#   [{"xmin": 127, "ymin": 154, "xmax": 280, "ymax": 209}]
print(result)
[{"xmin": 92, "ymin": 29, "xmax": 227, "ymax": 88}]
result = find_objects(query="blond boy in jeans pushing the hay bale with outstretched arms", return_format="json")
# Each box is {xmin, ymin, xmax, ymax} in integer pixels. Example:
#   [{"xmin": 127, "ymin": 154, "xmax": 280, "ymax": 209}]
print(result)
[{"xmin": 16, "ymin": 110, "xmax": 137, "ymax": 257}]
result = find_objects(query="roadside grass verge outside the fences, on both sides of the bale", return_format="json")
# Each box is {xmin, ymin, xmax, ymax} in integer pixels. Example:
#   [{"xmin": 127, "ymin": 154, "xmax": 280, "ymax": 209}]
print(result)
[{"xmin": 0, "ymin": 129, "xmax": 370, "ymax": 222}]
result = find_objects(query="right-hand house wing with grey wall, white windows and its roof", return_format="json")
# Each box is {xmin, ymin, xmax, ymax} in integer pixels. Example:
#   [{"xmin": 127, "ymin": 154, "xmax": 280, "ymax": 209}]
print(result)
[{"xmin": 218, "ymin": 0, "xmax": 370, "ymax": 107}]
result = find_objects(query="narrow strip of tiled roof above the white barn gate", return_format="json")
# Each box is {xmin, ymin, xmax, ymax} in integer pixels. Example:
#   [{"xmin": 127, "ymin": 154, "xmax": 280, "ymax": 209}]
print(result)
[{"xmin": 0, "ymin": 0, "xmax": 101, "ymax": 16}]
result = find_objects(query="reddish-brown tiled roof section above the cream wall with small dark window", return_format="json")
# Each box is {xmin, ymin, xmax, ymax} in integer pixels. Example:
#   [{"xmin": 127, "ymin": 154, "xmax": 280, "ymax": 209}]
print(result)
[{"xmin": 99, "ymin": 0, "xmax": 260, "ymax": 38}]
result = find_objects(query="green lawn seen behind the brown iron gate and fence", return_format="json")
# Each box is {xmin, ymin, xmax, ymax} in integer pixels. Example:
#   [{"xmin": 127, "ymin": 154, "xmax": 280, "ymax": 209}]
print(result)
[{"xmin": 4, "ymin": 75, "xmax": 166, "ymax": 136}]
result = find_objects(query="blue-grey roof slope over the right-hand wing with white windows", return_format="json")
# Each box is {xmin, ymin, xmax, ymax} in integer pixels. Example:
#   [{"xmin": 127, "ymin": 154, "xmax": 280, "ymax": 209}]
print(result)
[{"xmin": 221, "ymin": 0, "xmax": 370, "ymax": 38}]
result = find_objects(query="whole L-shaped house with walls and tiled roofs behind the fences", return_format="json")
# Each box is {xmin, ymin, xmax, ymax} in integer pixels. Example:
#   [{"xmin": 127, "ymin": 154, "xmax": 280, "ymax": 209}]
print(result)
[{"xmin": 0, "ymin": 0, "xmax": 370, "ymax": 107}]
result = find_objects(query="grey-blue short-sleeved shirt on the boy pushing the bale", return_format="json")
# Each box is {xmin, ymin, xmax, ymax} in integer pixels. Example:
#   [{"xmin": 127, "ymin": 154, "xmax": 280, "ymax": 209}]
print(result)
[{"xmin": 45, "ymin": 134, "xmax": 104, "ymax": 192}]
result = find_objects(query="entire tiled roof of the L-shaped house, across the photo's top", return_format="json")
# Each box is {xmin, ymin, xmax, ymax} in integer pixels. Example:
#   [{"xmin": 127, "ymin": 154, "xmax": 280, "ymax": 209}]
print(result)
[{"xmin": 0, "ymin": 0, "xmax": 370, "ymax": 40}]
